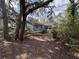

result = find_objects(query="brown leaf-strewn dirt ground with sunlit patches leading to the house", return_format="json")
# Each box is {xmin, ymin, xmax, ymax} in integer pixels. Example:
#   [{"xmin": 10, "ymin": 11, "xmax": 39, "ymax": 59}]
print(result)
[{"xmin": 0, "ymin": 34, "xmax": 79, "ymax": 59}]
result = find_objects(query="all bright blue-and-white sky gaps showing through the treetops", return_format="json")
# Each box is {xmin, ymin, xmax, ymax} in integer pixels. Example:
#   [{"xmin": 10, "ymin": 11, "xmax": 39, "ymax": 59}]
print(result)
[{"xmin": 5, "ymin": 0, "xmax": 69, "ymax": 15}]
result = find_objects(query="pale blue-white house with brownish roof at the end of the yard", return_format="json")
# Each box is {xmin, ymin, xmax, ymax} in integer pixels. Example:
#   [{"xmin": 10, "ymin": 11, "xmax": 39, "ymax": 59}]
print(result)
[{"xmin": 27, "ymin": 21, "xmax": 52, "ymax": 32}]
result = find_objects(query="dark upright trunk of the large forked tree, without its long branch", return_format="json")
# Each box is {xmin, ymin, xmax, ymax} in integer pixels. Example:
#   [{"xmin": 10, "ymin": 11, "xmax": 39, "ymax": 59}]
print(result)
[{"xmin": 19, "ymin": 0, "xmax": 26, "ymax": 41}]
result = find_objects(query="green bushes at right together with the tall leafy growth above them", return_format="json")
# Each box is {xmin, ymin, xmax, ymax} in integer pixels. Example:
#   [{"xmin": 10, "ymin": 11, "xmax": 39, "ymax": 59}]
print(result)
[{"xmin": 51, "ymin": 3, "xmax": 79, "ymax": 48}]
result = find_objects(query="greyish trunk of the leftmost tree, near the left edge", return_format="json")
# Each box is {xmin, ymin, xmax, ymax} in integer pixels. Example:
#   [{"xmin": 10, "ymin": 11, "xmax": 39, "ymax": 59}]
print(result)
[{"xmin": 0, "ymin": 0, "xmax": 9, "ymax": 40}]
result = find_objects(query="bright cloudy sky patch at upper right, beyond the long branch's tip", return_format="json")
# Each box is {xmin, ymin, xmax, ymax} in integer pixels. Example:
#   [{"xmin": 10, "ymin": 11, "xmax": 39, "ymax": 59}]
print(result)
[{"xmin": 54, "ymin": 0, "xmax": 69, "ymax": 15}]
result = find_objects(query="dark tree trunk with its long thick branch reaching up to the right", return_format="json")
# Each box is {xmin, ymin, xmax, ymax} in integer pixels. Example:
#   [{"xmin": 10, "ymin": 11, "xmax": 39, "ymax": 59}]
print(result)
[{"xmin": 19, "ymin": 0, "xmax": 53, "ymax": 41}]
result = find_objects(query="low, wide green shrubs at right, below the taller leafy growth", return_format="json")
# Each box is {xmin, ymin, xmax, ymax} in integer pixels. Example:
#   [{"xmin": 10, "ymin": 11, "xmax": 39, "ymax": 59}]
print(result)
[{"xmin": 51, "ymin": 21, "xmax": 79, "ymax": 48}]
